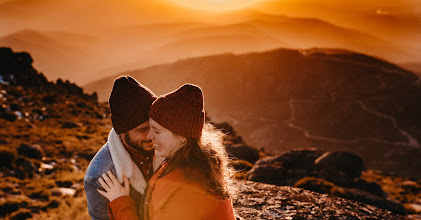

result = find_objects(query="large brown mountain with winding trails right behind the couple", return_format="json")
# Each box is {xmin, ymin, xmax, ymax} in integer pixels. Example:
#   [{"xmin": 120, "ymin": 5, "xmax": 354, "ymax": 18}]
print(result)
[{"xmin": 84, "ymin": 49, "xmax": 421, "ymax": 177}]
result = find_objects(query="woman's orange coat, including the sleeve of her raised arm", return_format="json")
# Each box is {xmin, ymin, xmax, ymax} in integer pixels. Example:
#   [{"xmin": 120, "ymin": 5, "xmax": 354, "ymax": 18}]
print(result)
[{"xmin": 109, "ymin": 169, "xmax": 235, "ymax": 220}]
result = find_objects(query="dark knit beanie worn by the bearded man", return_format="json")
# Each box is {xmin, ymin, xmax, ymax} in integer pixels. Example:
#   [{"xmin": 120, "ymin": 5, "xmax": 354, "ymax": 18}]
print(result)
[{"xmin": 108, "ymin": 76, "xmax": 156, "ymax": 134}]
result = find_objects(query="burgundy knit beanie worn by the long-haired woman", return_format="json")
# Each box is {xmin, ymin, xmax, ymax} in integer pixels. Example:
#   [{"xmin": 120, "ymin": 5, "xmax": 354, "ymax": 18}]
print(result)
[{"xmin": 149, "ymin": 84, "xmax": 205, "ymax": 138}]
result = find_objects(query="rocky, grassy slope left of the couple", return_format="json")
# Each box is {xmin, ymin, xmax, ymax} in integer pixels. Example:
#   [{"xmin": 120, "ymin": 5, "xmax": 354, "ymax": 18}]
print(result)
[{"xmin": 0, "ymin": 48, "xmax": 111, "ymax": 219}]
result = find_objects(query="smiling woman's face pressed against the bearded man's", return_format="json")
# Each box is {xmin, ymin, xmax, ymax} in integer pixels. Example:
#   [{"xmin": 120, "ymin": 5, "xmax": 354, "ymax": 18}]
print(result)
[{"xmin": 147, "ymin": 118, "xmax": 186, "ymax": 158}]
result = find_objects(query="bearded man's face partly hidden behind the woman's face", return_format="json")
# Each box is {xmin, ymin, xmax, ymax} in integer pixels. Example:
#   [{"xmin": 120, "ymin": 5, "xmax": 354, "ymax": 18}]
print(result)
[{"xmin": 121, "ymin": 121, "xmax": 154, "ymax": 151}]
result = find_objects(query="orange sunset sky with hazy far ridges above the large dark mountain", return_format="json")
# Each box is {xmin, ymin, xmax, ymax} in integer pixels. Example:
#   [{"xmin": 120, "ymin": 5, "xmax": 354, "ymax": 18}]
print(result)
[{"xmin": 0, "ymin": 0, "xmax": 421, "ymax": 83}]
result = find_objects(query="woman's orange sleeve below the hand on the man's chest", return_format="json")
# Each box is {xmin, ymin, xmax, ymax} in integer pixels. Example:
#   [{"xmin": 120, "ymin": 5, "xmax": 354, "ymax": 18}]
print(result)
[{"xmin": 107, "ymin": 196, "xmax": 139, "ymax": 220}]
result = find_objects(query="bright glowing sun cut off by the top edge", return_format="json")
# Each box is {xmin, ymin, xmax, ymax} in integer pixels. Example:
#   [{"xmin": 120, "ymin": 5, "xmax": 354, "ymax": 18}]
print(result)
[{"xmin": 170, "ymin": 0, "xmax": 259, "ymax": 11}]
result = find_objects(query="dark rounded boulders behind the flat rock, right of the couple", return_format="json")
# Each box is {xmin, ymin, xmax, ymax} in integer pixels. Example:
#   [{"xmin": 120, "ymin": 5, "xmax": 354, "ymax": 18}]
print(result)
[{"xmin": 247, "ymin": 150, "xmax": 405, "ymax": 214}]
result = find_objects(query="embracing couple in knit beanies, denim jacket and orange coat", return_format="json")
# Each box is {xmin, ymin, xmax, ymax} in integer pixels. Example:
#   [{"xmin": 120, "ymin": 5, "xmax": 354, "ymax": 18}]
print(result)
[{"xmin": 84, "ymin": 76, "xmax": 235, "ymax": 220}]
